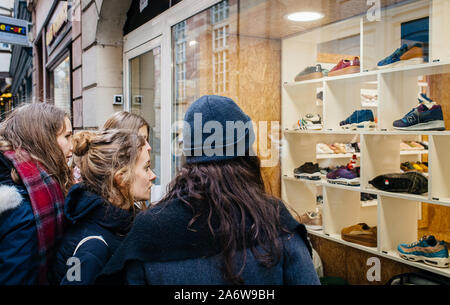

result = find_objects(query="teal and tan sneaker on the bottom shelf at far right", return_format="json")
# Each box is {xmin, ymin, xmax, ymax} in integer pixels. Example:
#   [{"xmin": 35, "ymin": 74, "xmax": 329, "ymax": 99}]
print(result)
[{"xmin": 397, "ymin": 235, "xmax": 450, "ymax": 268}]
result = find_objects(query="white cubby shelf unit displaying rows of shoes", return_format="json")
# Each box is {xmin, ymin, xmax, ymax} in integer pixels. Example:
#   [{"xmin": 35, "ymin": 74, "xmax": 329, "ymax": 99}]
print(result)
[{"xmin": 281, "ymin": 0, "xmax": 450, "ymax": 277}]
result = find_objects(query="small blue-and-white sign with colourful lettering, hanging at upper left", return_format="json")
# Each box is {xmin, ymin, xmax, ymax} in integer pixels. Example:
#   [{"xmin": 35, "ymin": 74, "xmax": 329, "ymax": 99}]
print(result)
[{"xmin": 0, "ymin": 16, "xmax": 31, "ymax": 47}]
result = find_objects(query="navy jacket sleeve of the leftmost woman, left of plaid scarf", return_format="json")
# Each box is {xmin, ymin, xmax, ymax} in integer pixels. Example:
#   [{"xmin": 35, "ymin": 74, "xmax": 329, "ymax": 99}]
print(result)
[{"xmin": 0, "ymin": 200, "xmax": 39, "ymax": 285}]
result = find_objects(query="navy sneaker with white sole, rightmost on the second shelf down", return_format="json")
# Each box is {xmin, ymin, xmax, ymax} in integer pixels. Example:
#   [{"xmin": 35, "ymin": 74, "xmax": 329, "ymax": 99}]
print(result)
[{"xmin": 393, "ymin": 103, "xmax": 445, "ymax": 130}]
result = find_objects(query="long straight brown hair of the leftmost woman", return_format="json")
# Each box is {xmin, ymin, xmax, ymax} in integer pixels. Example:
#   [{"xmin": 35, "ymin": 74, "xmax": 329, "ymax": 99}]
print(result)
[{"xmin": 0, "ymin": 103, "xmax": 72, "ymax": 195}]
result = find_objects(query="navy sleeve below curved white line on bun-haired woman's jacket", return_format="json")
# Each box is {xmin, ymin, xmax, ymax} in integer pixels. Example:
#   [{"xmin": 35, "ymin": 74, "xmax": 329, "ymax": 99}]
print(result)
[{"xmin": 60, "ymin": 239, "xmax": 111, "ymax": 285}]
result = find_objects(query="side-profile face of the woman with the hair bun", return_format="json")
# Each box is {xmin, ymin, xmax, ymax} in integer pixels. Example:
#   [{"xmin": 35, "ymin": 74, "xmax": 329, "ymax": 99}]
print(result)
[{"xmin": 131, "ymin": 144, "xmax": 156, "ymax": 201}]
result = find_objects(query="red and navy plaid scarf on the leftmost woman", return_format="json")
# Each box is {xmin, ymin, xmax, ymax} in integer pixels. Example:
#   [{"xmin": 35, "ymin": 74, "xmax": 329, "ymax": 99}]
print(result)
[{"xmin": 4, "ymin": 150, "xmax": 65, "ymax": 284}]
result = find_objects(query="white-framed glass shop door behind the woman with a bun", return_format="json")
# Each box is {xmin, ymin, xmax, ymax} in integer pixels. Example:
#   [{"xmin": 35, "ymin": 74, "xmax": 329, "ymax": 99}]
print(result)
[{"xmin": 127, "ymin": 45, "xmax": 161, "ymax": 203}]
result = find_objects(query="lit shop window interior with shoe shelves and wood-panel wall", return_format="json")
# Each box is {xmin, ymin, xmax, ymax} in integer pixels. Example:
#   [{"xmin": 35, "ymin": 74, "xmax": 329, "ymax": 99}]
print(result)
[{"xmin": 179, "ymin": 0, "xmax": 450, "ymax": 284}]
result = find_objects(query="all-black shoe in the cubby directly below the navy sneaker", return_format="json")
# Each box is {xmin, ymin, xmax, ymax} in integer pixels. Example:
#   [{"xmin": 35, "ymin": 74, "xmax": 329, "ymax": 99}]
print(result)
[{"xmin": 369, "ymin": 172, "xmax": 428, "ymax": 195}]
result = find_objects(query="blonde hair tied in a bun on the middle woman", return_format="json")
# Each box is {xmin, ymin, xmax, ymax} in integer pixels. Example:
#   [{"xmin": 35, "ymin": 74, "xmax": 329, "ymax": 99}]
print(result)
[{"xmin": 73, "ymin": 129, "xmax": 145, "ymax": 210}]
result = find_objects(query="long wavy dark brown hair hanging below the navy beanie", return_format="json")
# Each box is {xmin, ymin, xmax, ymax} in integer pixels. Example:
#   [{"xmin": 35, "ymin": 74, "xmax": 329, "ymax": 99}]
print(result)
[{"xmin": 160, "ymin": 156, "xmax": 287, "ymax": 284}]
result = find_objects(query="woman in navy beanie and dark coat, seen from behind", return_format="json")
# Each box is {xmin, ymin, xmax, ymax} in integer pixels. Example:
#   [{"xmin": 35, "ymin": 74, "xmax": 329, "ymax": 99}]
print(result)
[{"xmin": 98, "ymin": 95, "xmax": 320, "ymax": 285}]
